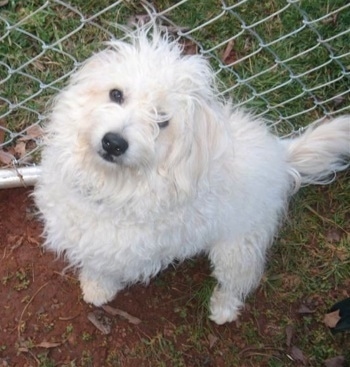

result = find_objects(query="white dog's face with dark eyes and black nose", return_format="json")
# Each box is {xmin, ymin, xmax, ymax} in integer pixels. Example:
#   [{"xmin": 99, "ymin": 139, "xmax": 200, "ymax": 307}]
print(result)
[{"xmin": 68, "ymin": 49, "xmax": 179, "ymax": 167}]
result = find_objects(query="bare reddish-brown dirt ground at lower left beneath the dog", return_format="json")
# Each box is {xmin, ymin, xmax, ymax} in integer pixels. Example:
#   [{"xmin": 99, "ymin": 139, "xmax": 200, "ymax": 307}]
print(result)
[{"xmin": 0, "ymin": 189, "xmax": 241, "ymax": 367}]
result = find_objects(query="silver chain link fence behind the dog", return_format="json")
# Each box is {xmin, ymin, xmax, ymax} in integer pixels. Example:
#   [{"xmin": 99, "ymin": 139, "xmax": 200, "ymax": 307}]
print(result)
[{"xmin": 0, "ymin": 0, "xmax": 350, "ymax": 186}]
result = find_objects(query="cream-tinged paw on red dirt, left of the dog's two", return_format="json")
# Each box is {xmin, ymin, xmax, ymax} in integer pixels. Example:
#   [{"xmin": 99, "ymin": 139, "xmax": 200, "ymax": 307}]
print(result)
[{"xmin": 80, "ymin": 279, "xmax": 116, "ymax": 307}]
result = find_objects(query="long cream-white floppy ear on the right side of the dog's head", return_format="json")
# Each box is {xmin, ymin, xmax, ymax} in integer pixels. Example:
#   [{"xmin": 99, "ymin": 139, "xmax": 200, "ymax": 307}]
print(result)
[{"xmin": 160, "ymin": 96, "xmax": 227, "ymax": 200}]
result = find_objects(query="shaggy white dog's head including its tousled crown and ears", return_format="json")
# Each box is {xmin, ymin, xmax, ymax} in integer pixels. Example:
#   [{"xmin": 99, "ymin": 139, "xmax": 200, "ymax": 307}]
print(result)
[{"xmin": 47, "ymin": 29, "xmax": 224, "ymax": 197}]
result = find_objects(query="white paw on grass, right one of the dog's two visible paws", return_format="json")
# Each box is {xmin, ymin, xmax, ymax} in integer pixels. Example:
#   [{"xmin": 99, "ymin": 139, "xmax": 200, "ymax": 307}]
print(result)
[{"xmin": 210, "ymin": 286, "xmax": 244, "ymax": 325}]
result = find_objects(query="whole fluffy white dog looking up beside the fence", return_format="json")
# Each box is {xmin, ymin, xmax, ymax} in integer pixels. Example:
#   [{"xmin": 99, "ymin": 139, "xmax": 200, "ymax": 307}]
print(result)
[{"xmin": 35, "ymin": 28, "xmax": 350, "ymax": 324}]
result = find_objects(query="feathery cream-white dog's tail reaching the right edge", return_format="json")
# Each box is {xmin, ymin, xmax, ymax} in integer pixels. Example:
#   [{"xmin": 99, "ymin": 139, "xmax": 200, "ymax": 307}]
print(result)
[{"xmin": 283, "ymin": 115, "xmax": 350, "ymax": 186}]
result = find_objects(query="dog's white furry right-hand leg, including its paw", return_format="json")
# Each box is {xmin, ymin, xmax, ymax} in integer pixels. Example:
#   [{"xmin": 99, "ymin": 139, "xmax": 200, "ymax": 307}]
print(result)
[{"xmin": 209, "ymin": 236, "xmax": 267, "ymax": 325}]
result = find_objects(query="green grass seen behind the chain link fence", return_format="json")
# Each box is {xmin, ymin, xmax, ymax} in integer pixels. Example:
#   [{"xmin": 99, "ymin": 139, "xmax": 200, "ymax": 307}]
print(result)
[{"xmin": 0, "ymin": 0, "xmax": 350, "ymax": 139}]
